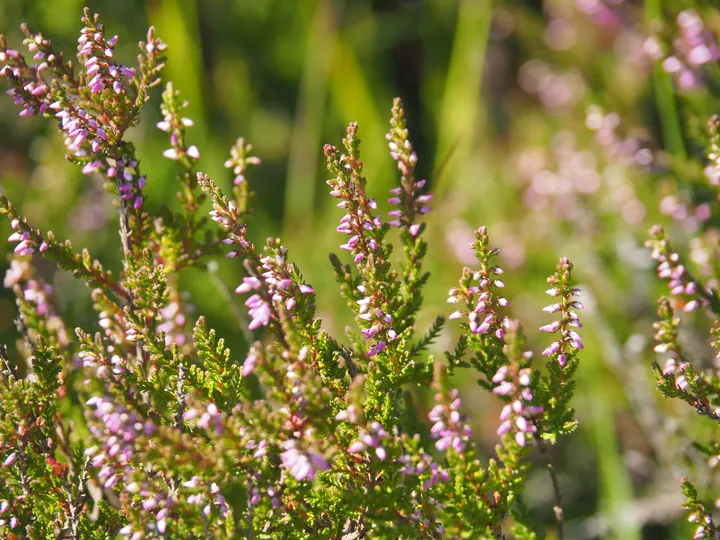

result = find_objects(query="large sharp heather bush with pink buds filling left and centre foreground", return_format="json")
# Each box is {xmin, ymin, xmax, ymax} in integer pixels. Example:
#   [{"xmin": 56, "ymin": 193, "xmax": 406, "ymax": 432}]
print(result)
[{"xmin": 0, "ymin": 9, "xmax": 584, "ymax": 539}]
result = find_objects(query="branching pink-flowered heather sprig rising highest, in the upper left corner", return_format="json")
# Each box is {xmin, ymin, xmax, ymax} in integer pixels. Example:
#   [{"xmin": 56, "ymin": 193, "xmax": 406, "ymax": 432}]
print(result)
[{"xmin": 0, "ymin": 9, "xmax": 165, "ymax": 264}]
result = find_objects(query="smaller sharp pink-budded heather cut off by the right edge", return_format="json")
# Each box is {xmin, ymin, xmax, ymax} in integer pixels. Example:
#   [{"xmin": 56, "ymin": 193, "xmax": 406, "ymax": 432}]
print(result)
[{"xmin": 646, "ymin": 116, "xmax": 720, "ymax": 538}]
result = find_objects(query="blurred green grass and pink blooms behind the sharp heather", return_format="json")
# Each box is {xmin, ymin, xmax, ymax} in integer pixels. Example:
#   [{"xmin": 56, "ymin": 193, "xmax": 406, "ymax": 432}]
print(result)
[{"xmin": 0, "ymin": 0, "xmax": 718, "ymax": 539}]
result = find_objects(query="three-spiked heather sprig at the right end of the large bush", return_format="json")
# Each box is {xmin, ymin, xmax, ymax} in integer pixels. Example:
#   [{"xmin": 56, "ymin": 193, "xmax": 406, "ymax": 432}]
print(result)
[{"xmin": 447, "ymin": 248, "xmax": 583, "ymax": 537}]
